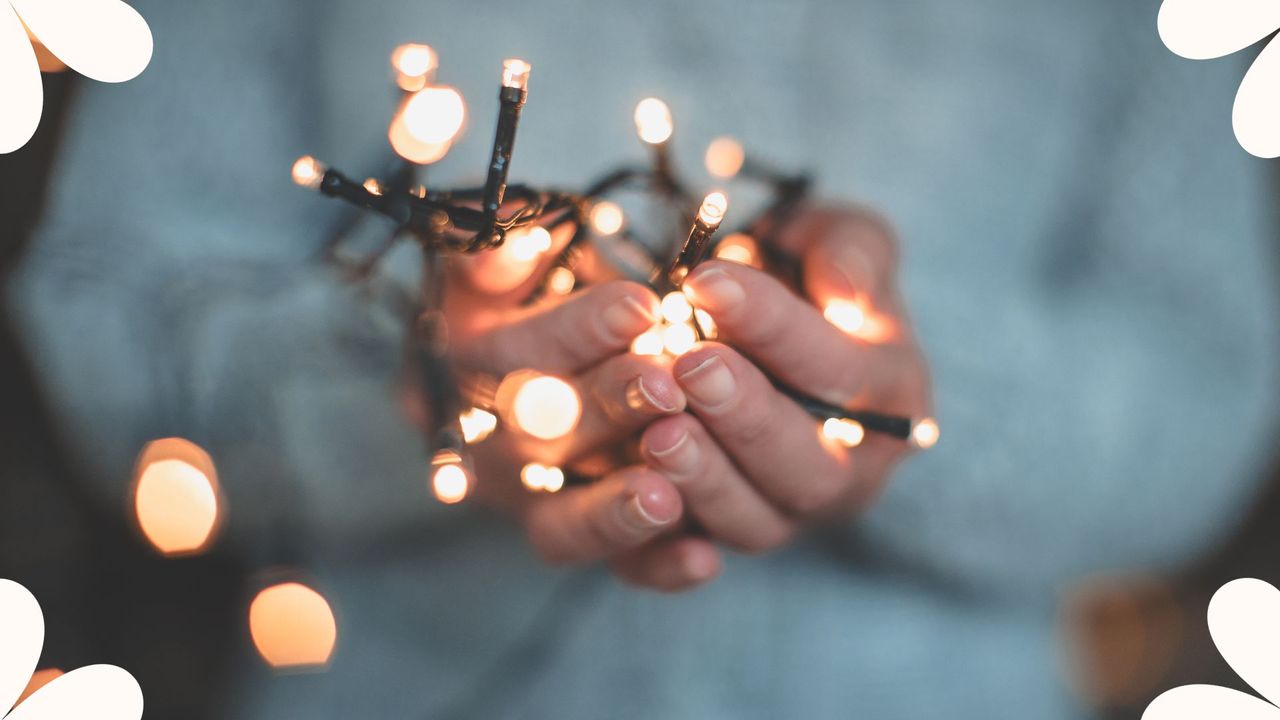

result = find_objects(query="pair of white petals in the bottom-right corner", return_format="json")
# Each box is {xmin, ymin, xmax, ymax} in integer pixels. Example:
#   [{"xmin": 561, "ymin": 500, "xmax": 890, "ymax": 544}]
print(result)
[{"xmin": 1142, "ymin": 578, "xmax": 1280, "ymax": 720}]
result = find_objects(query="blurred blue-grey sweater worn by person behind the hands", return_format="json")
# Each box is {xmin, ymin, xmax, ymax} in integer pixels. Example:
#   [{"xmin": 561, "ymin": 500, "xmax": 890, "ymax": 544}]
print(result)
[{"xmin": 9, "ymin": 0, "xmax": 1280, "ymax": 719}]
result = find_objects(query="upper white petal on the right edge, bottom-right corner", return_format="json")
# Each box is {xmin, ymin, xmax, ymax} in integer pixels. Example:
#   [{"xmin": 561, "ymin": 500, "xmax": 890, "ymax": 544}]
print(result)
[{"xmin": 1208, "ymin": 578, "xmax": 1280, "ymax": 702}]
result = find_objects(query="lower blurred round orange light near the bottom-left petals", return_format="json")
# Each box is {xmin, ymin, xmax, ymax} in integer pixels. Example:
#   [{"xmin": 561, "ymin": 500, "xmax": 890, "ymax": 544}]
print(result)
[{"xmin": 248, "ymin": 583, "xmax": 338, "ymax": 669}]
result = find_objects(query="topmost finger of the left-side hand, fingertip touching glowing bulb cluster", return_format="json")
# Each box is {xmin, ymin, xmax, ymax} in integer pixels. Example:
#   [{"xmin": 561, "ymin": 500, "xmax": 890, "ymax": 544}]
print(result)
[{"xmin": 458, "ymin": 282, "xmax": 658, "ymax": 378}]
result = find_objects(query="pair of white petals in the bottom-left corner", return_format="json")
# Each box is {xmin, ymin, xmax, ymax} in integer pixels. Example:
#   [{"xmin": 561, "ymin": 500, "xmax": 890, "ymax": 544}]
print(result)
[{"xmin": 0, "ymin": 579, "xmax": 142, "ymax": 720}]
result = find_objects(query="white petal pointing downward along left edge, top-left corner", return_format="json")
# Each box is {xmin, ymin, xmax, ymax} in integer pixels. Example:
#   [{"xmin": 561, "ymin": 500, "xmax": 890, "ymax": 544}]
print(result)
[{"xmin": 0, "ymin": 3, "xmax": 45, "ymax": 154}]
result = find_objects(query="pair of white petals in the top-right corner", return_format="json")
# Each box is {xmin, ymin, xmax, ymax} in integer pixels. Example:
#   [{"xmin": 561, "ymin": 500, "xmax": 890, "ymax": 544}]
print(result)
[{"xmin": 1157, "ymin": 0, "xmax": 1280, "ymax": 158}]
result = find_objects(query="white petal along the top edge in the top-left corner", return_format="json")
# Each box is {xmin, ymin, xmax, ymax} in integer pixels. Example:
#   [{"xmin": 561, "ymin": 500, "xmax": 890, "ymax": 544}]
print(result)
[{"xmin": 10, "ymin": 0, "xmax": 151, "ymax": 82}]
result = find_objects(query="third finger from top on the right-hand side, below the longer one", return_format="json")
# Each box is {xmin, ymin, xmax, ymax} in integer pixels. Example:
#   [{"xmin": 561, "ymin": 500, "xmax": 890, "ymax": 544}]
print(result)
[{"xmin": 640, "ymin": 414, "xmax": 794, "ymax": 553}]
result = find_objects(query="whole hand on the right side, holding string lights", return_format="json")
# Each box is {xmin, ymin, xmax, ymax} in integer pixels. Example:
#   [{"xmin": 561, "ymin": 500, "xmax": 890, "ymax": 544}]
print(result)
[{"xmin": 632, "ymin": 204, "xmax": 931, "ymax": 568}]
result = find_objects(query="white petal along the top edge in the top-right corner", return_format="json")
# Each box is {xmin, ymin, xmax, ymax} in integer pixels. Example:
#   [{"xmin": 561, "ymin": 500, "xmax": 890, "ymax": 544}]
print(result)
[{"xmin": 1156, "ymin": 0, "xmax": 1280, "ymax": 60}]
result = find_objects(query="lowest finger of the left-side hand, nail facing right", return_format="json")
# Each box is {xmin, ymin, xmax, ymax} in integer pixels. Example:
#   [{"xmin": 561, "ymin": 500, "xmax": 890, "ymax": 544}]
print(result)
[{"xmin": 525, "ymin": 466, "xmax": 682, "ymax": 565}]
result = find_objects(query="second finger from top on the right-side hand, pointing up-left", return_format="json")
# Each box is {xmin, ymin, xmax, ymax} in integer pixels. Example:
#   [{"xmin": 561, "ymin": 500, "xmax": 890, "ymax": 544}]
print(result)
[{"xmin": 675, "ymin": 343, "xmax": 873, "ymax": 518}]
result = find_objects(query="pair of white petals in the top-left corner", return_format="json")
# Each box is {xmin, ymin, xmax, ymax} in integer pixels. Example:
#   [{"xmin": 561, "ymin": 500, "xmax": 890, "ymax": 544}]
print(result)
[{"xmin": 0, "ymin": 0, "xmax": 151, "ymax": 154}]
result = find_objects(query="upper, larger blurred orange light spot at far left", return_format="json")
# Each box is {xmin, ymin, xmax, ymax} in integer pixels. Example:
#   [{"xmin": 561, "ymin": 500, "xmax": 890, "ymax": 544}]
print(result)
[{"xmin": 133, "ymin": 438, "xmax": 219, "ymax": 555}]
